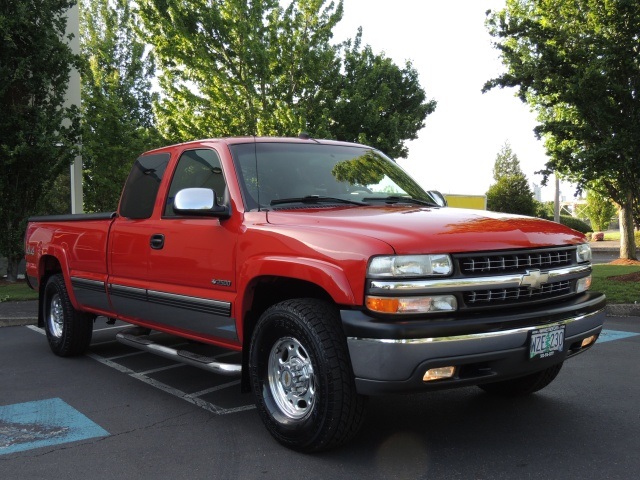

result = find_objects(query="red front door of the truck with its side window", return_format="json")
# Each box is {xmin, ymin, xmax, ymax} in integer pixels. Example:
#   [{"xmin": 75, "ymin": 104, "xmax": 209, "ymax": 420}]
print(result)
[{"xmin": 141, "ymin": 148, "xmax": 238, "ymax": 343}]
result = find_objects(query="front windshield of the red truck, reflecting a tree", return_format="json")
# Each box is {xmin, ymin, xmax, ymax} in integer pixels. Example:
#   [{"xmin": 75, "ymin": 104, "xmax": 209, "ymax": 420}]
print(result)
[{"xmin": 230, "ymin": 143, "xmax": 435, "ymax": 210}]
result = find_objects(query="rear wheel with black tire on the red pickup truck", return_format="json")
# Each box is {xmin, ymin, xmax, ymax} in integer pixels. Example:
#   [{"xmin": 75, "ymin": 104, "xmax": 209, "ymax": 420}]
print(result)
[{"xmin": 42, "ymin": 274, "xmax": 95, "ymax": 357}]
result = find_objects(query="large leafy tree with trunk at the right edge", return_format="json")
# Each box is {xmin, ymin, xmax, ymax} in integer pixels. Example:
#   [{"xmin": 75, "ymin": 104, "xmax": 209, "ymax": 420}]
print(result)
[{"xmin": 484, "ymin": 0, "xmax": 640, "ymax": 259}]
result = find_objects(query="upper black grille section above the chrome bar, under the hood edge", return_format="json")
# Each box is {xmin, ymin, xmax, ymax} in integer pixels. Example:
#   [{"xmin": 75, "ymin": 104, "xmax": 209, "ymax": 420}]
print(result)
[{"xmin": 458, "ymin": 249, "xmax": 574, "ymax": 275}]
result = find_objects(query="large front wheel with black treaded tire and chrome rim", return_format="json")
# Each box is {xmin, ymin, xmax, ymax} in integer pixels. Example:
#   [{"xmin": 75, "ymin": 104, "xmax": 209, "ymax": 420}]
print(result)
[{"xmin": 249, "ymin": 299, "xmax": 366, "ymax": 452}]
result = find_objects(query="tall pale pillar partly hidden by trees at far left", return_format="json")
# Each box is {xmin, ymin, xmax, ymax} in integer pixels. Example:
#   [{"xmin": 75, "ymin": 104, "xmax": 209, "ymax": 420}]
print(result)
[{"xmin": 65, "ymin": 3, "xmax": 83, "ymax": 213}]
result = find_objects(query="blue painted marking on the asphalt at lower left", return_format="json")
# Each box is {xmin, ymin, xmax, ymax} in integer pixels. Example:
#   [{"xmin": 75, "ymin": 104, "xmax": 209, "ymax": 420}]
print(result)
[{"xmin": 0, "ymin": 398, "xmax": 109, "ymax": 455}]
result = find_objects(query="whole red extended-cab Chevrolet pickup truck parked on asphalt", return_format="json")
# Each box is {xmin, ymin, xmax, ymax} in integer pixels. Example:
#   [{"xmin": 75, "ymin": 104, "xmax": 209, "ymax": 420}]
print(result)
[{"xmin": 25, "ymin": 137, "xmax": 605, "ymax": 451}]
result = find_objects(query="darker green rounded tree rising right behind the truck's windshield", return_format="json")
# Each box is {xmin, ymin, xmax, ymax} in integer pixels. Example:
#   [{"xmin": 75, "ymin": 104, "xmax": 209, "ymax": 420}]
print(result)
[{"xmin": 329, "ymin": 29, "xmax": 436, "ymax": 158}]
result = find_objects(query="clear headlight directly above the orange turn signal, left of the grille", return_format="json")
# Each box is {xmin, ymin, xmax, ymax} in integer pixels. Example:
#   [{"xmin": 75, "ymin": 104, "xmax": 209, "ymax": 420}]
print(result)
[{"xmin": 367, "ymin": 255, "xmax": 453, "ymax": 278}]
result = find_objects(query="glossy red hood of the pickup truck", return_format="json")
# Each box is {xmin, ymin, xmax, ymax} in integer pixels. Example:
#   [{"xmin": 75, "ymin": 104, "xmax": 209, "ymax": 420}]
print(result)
[{"xmin": 267, "ymin": 205, "xmax": 585, "ymax": 254}]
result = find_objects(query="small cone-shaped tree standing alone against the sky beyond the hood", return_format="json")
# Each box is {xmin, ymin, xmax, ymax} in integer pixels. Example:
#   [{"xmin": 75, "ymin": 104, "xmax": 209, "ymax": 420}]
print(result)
[{"xmin": 487, "ymin": 142, "xmax": 538, "ymax": 217}]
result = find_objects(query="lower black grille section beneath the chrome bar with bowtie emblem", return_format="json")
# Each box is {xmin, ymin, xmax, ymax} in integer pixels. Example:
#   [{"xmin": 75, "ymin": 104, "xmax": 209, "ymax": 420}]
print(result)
[{"xmin": 463, "ymin": 280, "xmax": 571, "ymax": 306}]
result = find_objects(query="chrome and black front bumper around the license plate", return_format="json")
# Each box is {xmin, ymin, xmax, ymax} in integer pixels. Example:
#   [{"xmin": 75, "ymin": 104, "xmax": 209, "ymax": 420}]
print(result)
[{"xmin": 341, "ymin": 292, "xmax": 605, "ymax": 395}]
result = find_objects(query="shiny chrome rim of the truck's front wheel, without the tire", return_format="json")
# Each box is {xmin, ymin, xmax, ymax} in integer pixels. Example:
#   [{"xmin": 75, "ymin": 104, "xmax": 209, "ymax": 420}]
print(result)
[{"xmin": 269, "ymin": 337, "xmax": 316, "ymax": 420}]
